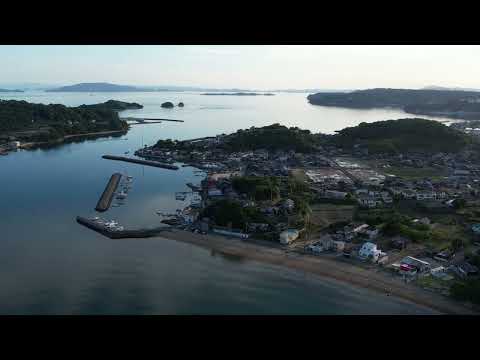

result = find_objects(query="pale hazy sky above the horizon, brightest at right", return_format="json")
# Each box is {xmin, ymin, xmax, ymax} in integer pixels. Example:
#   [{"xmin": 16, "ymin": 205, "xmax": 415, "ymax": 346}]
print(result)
[{"xmin": 0, "ymin": 45, "xmax": 480, "ymax": 89}]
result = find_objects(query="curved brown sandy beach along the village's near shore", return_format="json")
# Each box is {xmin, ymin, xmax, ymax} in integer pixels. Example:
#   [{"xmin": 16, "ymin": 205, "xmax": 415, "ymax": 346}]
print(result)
[{"xmin": 155, "ymin": 229, "xmax": 478, "ymax": 315}]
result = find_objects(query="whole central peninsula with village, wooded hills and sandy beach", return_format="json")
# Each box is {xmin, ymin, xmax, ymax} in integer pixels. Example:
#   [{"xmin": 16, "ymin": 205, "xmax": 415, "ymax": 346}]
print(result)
[{"xmin": 126, "ymin": 118, "xmax": 480, "ymax": 314}]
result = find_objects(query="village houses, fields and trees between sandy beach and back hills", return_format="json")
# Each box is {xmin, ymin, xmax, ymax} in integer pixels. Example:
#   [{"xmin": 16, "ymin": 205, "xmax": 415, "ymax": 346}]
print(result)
[{"xmin": 135, "ymin": 124, "xmax": 480, "ymax": 306}]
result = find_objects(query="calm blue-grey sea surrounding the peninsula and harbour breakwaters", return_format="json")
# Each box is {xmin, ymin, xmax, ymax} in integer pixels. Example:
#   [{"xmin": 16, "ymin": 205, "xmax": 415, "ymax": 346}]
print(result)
[{"xmin": 0, "ymin": 92, "xmax": 442, "ymax": 314}]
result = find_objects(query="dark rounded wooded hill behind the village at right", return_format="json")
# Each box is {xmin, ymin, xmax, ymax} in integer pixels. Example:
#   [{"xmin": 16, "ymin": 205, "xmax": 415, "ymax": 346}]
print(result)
[{"xmin": 331, "ymin": 118, "xmax": 468, "ymax": 153}]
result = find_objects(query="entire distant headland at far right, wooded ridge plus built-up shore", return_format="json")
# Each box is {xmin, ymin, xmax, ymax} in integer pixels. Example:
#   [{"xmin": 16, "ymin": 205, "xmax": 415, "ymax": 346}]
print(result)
[{"xmin": 307, "ymin": 88, "xmax": 480, "ymax": 120}]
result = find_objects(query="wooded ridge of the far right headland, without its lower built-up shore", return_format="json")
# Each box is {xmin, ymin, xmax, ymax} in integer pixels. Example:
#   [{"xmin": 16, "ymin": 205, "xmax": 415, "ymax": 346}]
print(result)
[{"xmin": 307, "ymin": 89, "xmax": 480, "ymax": 109}]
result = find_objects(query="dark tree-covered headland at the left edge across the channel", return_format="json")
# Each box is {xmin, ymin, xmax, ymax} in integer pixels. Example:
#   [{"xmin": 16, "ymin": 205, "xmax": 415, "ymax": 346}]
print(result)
[{"xmin": 0, "ymin": 100, "xmax": 143, "ymax": 147}]
